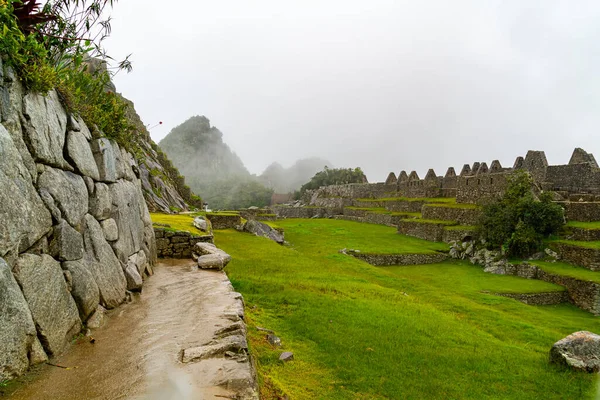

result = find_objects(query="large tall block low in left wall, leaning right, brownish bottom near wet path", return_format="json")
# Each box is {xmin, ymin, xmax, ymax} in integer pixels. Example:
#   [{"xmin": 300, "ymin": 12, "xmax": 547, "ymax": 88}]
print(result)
[{"xmin": 14, "ymin": 254, "xmax": 81, "ymax": 355}]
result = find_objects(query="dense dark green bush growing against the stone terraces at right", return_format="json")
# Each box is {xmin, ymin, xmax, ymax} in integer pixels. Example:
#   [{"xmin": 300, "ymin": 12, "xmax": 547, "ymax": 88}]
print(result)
[{"xmin": 479, "ymin": 171, "xmax": 564, "ymax": 257}]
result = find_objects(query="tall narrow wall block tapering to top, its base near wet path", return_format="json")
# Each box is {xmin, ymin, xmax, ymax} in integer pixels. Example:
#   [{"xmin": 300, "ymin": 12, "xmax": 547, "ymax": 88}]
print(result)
[{"xmin": 83, "ymin": 214, "xmax": 127, "ymax": 309}]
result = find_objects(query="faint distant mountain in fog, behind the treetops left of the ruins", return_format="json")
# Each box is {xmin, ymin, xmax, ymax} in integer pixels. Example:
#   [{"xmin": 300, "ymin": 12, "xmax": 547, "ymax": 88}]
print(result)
[{"xmin": 258, "ymin": 157, "xmax": 333, "ymax": 193}]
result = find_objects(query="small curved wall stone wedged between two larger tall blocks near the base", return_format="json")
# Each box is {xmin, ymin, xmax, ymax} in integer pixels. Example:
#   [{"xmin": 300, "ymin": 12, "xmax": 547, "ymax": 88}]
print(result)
[{"xmin": 62, "ymin": 261, "xmax": 100, "ymax": 322}]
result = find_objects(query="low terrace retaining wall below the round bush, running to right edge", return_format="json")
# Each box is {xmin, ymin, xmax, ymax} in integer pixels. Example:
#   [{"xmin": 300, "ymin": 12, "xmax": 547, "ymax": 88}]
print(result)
[{"xmin": 488, "ymin": 263, "xmax": 600, "ymax": 315}]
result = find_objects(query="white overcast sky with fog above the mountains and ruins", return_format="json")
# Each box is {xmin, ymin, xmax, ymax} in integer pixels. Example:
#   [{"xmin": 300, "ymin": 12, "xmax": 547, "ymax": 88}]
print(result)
[{"xmin": 107, "ymin": 0, "xmax": 600, "ymax": 182}]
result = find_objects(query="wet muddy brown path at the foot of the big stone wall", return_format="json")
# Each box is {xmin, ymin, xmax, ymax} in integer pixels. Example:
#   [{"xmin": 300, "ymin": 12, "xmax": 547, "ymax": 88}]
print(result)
[{"xmin": 8, "ymin": 260, "xmax": 245, "ymax": 400}]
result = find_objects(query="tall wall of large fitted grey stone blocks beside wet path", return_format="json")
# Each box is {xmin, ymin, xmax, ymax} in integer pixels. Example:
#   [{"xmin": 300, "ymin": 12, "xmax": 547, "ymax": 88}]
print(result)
[{"xmin": 0, "ymin": 65, "xmax": 156, "ymax": 381}]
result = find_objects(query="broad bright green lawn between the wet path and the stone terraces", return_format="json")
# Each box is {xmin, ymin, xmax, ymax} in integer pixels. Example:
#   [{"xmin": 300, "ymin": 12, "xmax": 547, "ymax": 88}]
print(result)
[{"xmin": 215, "ymin": 220, "xmax": 600, "ymax": 400}]
